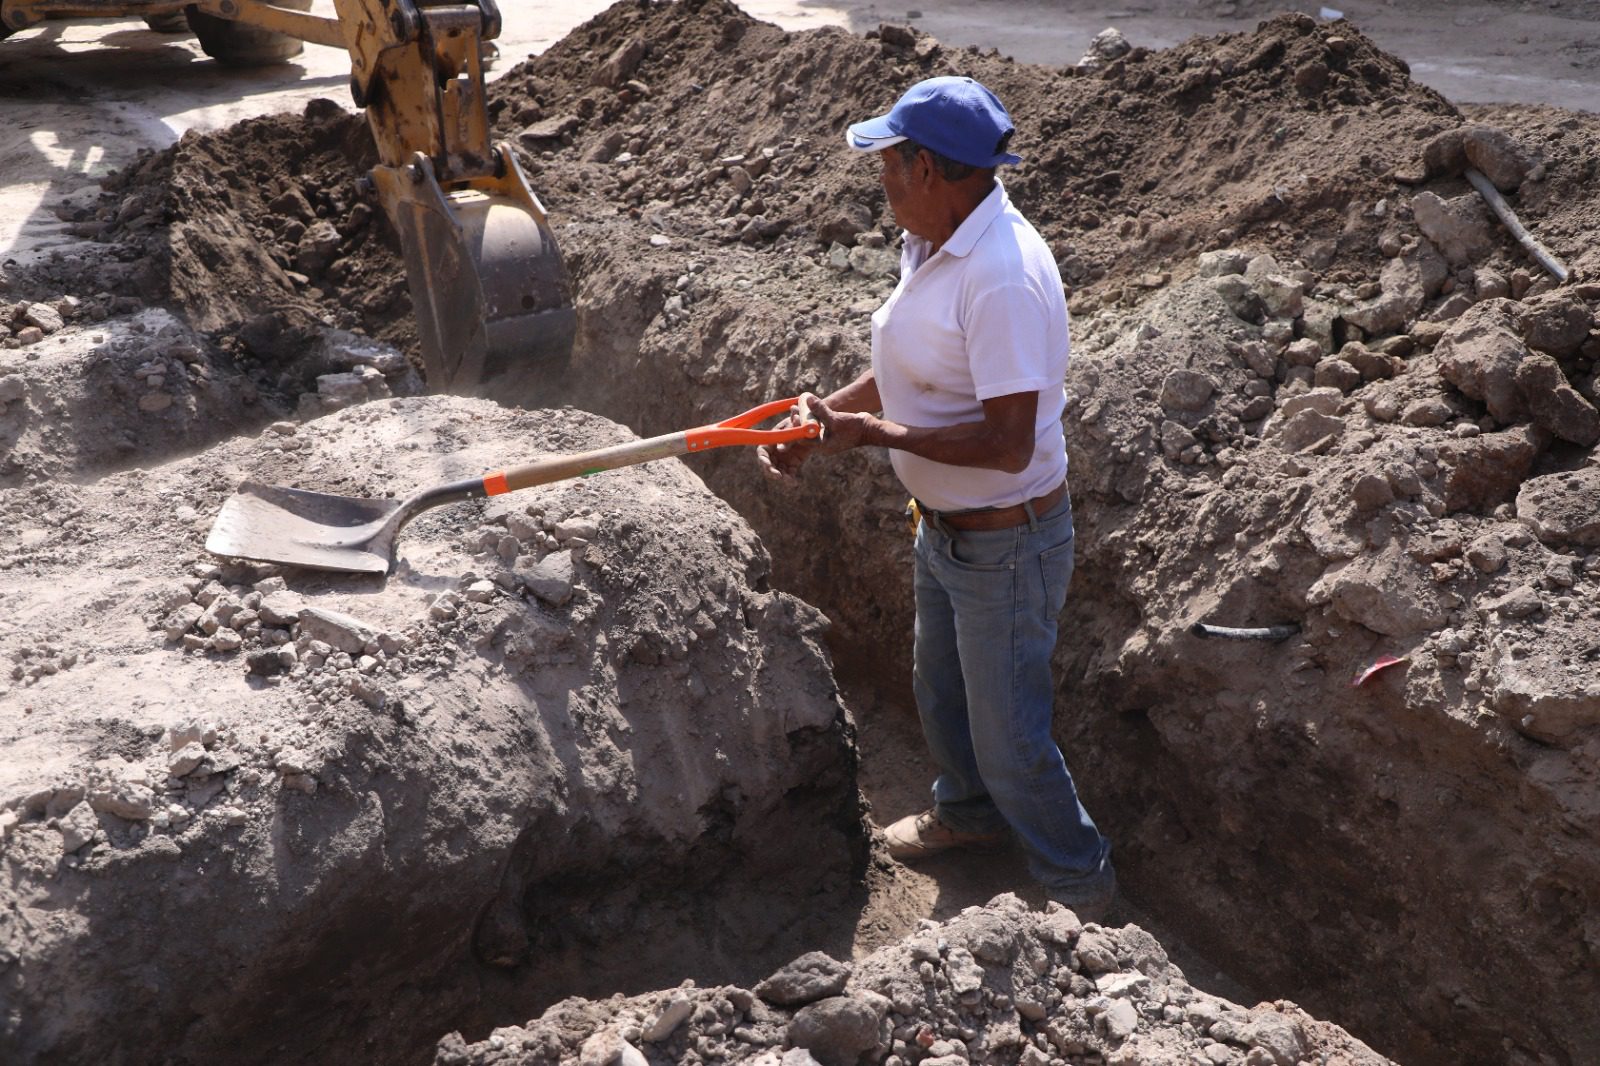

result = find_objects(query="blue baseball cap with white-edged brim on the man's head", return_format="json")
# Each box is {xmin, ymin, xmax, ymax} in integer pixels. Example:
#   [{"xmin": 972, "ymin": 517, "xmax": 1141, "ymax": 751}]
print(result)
[{"xmin": 845, "ymin": 77, "xmax": 1022, "ymax": 168}]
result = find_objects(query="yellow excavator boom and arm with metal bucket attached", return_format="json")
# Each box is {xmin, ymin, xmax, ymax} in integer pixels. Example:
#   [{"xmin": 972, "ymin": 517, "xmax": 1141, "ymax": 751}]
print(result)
[{"xmin": 0, "ymin": 0, "xmax": 578, "ymax": 393}]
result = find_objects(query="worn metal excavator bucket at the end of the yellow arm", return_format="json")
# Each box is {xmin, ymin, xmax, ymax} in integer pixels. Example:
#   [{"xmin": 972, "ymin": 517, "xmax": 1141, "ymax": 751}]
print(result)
[{"xmin": 373, "ymin": 146, "xmax": 578, "ymax": 403}]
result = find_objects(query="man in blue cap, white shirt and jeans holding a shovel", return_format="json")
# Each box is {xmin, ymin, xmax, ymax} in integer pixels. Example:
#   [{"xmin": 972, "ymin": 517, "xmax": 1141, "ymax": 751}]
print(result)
[{"xmin": 760, "ymin": 77, "xmax": 1117, "ymax": 919}]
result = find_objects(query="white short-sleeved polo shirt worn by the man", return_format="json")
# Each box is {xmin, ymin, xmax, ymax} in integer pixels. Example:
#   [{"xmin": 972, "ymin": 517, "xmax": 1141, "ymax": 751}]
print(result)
[{"xmin": 872, "ymin": 181, "xmax": 1070, "ymax": 511}]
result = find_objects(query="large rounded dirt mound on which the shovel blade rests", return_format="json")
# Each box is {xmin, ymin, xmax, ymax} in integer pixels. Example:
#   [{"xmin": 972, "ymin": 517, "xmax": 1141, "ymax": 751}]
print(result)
[{"xmin": 0, "ymin": 397, "xmax": 866, "ymax": 1061}]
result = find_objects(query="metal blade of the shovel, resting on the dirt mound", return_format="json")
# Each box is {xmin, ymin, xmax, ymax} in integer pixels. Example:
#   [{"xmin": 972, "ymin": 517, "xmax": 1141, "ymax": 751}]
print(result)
[{"xmin": 205, "ymin": 482, "xmax": 402, "ymax": 573}]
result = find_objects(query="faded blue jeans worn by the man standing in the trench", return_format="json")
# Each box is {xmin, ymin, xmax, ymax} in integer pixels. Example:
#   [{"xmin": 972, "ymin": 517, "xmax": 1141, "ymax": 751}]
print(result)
[{"xmin": 914, "ymin": 499, "xmax": 1115, "ymax": 903}]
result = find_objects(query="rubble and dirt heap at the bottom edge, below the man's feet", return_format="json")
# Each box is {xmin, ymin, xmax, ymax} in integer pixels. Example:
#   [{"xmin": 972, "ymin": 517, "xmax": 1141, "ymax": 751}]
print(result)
[{"xmin": 434, "ymin": 896, "xmax": 1387, "ymax": 1066}]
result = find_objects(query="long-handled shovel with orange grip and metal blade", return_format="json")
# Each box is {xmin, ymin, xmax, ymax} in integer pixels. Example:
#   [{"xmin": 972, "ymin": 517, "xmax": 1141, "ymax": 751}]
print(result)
[{"xmin": 205, "ymin": 399, "xmax": 822, "ymax": 573}]
